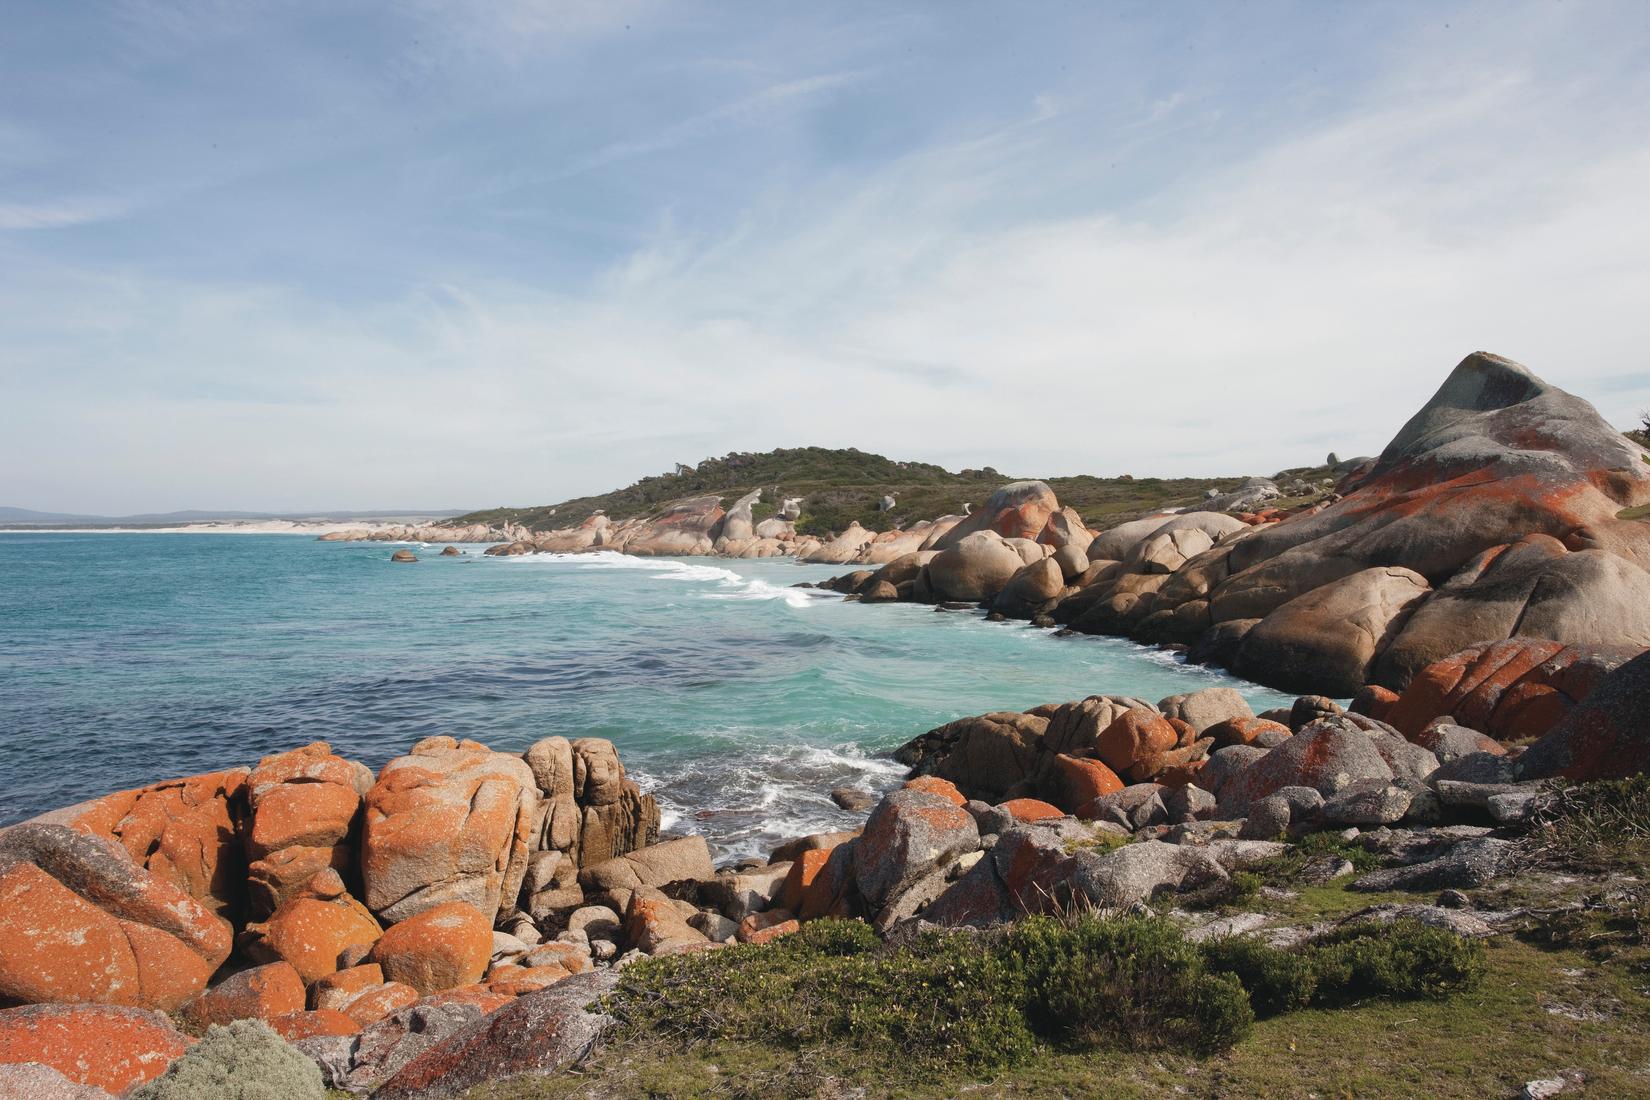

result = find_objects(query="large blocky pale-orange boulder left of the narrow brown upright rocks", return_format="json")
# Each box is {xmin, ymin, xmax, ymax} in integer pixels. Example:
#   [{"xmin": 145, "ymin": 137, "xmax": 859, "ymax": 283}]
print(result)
[{"xmin": 361, "ymin": 737, "xmax": 538, "ymax": 922}]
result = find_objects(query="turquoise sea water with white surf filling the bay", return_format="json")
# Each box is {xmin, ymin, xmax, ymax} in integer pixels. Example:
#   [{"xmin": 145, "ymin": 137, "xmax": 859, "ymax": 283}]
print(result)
[{"xmin": 0, "ymin": 534, "xmax": 1287, "ymax": 854}]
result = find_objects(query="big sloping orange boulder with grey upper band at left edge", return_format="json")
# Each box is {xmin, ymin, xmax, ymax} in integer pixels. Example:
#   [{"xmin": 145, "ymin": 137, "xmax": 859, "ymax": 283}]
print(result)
[{"xmin": 0, "ymin": 823, "xmax": 233, "ymax": 1011}]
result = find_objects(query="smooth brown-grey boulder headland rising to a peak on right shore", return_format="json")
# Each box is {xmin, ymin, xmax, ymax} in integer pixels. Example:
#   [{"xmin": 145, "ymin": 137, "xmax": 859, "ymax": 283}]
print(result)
[{"xmin": 818, "ymin": 351, "xmax": 1650, "ymax": 695}]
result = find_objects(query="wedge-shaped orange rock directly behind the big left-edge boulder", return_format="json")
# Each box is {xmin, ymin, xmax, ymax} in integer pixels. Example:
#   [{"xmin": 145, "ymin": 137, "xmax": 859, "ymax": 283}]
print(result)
[{"xmin": 68, "ymin": 769, "xmax": 246, "ymax": 920}]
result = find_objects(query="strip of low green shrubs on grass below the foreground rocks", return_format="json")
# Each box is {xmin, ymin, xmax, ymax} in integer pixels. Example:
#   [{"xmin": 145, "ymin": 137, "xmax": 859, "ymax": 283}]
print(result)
[{"xmin": 584, "ymin": 914, "xmax": 1483, "ymax": 1077}]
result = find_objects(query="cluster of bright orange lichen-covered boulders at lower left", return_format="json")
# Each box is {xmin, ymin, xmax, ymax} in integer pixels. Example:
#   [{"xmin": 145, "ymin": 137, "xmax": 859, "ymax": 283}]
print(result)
[{"xmin": 0, "ymin": 737, "xmax": 656, "ymax": 1095}]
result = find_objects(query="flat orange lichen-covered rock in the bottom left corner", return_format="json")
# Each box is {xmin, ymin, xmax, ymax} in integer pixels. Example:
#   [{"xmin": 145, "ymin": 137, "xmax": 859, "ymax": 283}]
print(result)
[{"xmin": 0, "ymin": 1004, "xmax": 190, "ymax": 1095}]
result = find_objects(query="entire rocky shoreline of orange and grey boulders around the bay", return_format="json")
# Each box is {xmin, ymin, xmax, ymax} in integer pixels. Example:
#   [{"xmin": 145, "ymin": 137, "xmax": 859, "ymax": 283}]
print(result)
[{"xmin": 0, "ymin": 355, "xmax": 1650, "ymax": 1100}]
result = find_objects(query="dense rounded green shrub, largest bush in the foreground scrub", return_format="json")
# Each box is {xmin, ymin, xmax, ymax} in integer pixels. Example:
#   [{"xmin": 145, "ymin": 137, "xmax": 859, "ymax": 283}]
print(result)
[{"xmin": 1005, "ymin": 915, "xmax": 1254, "ymax": 1051}]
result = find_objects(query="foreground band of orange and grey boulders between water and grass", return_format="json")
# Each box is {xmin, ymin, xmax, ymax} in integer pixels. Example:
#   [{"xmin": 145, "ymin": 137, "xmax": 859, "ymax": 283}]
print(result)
[{"xmin": 0, "ymin": 636, "xmax": 1650, "ymax": 1097}]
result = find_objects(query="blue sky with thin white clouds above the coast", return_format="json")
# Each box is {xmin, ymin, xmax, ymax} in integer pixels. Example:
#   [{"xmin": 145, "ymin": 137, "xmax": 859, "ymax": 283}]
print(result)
[{"xmin": 0, "ymin": 0, "xmax": 1650, "ymax": 515}]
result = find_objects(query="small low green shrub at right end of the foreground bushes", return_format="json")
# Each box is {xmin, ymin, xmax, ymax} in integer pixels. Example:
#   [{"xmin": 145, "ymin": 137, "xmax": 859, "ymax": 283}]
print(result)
[{"xmin": 1305, "ymin": 920, "xmax": 1483, "ymax": 1004}]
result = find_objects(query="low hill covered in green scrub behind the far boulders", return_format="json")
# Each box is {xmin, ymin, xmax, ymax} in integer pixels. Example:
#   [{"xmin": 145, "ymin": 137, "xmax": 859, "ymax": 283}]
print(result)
[{"xmin": 454, "ymin": 447, "xmax": 1327, "ymax": 534}]
